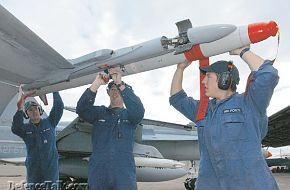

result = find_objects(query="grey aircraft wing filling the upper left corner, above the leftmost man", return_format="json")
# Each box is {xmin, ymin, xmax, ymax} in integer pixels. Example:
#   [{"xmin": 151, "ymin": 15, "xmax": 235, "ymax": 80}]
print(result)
[{"xmin": 0, "ymin": 5, "xmax": 73, "ymax": 114}]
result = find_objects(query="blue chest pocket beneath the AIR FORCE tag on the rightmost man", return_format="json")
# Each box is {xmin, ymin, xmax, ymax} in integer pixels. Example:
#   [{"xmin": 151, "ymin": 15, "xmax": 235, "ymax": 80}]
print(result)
[{"xmin": 223, "ymin": 114, "xmax": 246, "ymax": 141}]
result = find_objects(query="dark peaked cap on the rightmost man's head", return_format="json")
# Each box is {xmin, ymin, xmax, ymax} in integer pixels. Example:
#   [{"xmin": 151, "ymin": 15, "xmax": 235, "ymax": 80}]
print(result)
[{"xmin": 199, "ymin": 61, "xmax": 240, "ymax": 84}]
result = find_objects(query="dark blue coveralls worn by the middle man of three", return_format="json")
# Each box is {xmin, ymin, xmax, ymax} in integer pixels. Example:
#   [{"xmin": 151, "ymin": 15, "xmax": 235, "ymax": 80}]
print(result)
[{"xmin": 77, "ymin": 86, "xmax": 144, "ymax": 190}]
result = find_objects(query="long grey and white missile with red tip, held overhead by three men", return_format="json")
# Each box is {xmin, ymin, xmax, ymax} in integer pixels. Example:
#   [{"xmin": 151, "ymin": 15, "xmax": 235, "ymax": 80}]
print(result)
[{"xmin": 19, "ymin": 20, "xmax": 278, "ymax": 95}]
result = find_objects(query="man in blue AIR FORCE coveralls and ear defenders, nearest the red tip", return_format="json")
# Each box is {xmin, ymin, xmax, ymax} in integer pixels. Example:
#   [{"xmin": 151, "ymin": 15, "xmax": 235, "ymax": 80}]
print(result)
[{"xmin": 170, "ymin": 47, "xmax": 279, "ymax": 190}]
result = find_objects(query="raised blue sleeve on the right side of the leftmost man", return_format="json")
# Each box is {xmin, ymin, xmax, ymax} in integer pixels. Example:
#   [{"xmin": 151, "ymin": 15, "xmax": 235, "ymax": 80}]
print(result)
[{"xmin": 49, "ymin": 92, "xmax": 63, "ymax": 127}]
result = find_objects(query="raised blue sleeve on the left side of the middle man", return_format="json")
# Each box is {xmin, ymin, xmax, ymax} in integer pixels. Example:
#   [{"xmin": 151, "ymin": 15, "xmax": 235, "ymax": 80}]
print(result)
[{"xmin": 76, "ymin": 88, "xmax": 105, "ymax": 124}]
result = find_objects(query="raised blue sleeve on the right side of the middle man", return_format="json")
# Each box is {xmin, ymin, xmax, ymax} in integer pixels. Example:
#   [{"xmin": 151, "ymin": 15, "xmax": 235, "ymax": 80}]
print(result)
[{"xmin": 121, "ymin": 86, "xmax": 145, "ymax": 125}]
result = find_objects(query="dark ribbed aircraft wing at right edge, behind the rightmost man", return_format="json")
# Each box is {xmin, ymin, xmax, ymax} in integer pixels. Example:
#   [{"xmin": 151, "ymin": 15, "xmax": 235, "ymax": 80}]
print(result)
[{"xmin": 262, "ymin": 106, "xmax": 290, "ymax": 147}]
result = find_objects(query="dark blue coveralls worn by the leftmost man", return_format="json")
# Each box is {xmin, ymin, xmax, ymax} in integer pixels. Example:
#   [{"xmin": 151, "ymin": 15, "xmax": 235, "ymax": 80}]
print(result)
[{"xmin": 11, "ymin": 92, "xmax": 63, "ymax": 189}]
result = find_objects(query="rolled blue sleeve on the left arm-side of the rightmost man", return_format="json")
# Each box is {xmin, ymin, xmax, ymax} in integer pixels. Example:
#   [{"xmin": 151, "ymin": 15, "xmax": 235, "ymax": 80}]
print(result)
[{"xmin": 169, "ymin": 90, "xmax": 199, "ymax": 122}]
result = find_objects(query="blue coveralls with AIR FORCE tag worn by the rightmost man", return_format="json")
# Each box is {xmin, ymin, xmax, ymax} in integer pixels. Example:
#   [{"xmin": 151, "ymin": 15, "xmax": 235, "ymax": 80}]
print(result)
[{"xmin": 170, "ymin": 60, "xmax": 279, "ymax": 190}]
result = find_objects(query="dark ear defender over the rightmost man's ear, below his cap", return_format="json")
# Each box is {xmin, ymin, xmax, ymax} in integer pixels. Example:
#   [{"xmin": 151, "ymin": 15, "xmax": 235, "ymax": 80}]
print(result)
[{"xmin": 218, "ymin": 61, "xmax": 233, "ymax": 90}]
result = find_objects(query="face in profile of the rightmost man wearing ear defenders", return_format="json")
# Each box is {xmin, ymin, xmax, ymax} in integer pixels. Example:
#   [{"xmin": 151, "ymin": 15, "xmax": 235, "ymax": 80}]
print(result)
[{"xmin": 202, "ymin": 72, "xmax": 220, "ymax": 98}]
